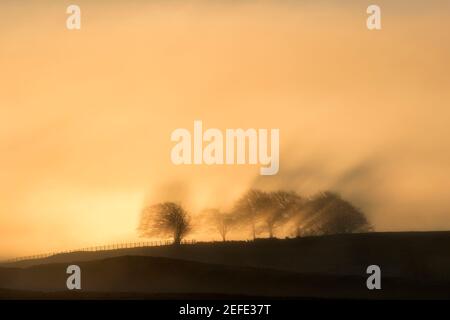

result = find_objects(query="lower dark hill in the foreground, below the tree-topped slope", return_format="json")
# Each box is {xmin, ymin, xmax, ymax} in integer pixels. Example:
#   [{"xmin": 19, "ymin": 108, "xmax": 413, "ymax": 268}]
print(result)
[{"xmin": 0, "ymin": 256, "xmax": 450, "ymax": 299}]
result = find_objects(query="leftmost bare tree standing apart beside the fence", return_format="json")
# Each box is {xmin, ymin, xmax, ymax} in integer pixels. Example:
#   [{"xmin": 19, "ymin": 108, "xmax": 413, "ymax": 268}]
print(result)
[{"xmin": 138, "ymin": 202, "xmax": 191, "ymax": 245}]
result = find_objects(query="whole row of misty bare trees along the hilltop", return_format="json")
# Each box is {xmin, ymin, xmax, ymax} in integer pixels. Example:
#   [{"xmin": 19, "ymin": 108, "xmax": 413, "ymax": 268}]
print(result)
[{"xmin": 138, "ymin": 189, "xmax": 373, "ymax": 244}]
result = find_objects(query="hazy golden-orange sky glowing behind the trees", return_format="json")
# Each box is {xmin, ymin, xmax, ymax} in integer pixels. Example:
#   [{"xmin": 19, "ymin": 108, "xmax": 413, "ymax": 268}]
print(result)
[{"xmin": 0, "ymin": 0, "xmax": 450, "ymax": 258}]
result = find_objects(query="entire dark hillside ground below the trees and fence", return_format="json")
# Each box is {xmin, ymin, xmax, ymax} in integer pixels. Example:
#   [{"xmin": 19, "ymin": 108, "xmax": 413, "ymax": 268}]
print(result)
[{"xmin": 0, "ymin": 232, "xmax": 450, "ymax": 299}]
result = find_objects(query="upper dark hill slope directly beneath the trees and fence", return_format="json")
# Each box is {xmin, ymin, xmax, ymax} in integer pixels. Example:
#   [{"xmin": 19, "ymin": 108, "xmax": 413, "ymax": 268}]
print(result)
[{"xmin": 3, "ymin": 232, "xmax": 450, "ymax": 282}]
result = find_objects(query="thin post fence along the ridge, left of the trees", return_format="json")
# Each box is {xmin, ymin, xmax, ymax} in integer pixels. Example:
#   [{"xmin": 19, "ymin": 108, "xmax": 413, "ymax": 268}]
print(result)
[{"xmin": 0, "ymin": 240, "xmax": 196, "ymax": 263}]
